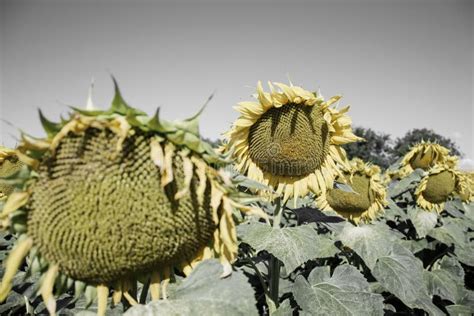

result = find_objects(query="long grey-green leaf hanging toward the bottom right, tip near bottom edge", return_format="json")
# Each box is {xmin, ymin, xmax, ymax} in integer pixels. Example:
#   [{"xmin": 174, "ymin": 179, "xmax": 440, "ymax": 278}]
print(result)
[{"xmin": 372, "ymin": 244, "xmax": 443, "ymax": 315}]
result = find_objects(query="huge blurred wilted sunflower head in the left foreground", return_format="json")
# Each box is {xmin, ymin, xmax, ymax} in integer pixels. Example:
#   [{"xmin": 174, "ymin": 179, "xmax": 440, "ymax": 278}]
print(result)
[{"xmin": 0, "ymin": 82, "xmax": 263, "ymax": 315}]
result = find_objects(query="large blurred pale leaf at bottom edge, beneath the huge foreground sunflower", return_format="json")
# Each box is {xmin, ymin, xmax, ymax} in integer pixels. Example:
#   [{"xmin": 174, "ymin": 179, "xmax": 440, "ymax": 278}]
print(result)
[{"xmin": 124, "ymin": 260, "xmax": 258, "ymax": 316}]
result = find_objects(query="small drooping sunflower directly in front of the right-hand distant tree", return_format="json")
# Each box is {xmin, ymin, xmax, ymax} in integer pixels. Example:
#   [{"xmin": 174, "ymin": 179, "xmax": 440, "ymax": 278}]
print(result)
[{"xmin": 390, "ymin": 141, "xmax": 457, "ymax": 178}]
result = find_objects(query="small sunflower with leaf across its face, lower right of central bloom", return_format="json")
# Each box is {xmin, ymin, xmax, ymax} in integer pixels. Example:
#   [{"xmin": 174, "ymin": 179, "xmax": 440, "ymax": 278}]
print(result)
[{"xmin": 316, "ymin": 158, "xmax": 387, "ymax": 224}]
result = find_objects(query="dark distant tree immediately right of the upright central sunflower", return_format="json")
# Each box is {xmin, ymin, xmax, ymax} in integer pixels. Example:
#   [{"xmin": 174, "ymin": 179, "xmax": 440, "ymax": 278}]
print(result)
[{"xmin": 344, "ymin": 127, "xmax": 391, "ymax": 169}]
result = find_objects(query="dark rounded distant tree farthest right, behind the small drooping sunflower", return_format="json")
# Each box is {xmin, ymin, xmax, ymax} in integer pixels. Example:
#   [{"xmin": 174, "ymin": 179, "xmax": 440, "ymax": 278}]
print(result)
[{"xmin": 391, "ymin": 128, "xmax": 462, "ymax": 161}]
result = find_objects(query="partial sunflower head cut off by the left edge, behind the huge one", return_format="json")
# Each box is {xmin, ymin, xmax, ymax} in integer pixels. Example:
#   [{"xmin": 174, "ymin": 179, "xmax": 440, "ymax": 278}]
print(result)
[{"xmin": 0, "ymin": 146, "xmax": 23, "ymax": 201}]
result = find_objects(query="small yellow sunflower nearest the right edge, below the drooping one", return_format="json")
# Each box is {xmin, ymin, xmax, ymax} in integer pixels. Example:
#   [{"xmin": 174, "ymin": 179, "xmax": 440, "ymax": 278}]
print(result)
[{"xmin": 415, "ymin": 163, "xmax": 473, "ymax": 213}]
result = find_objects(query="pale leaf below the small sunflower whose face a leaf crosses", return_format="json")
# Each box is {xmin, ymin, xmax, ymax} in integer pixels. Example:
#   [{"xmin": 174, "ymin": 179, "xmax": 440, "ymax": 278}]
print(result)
[{"xmin": 338, "ymin": 223, "xmax": 398, "ymax": 269}]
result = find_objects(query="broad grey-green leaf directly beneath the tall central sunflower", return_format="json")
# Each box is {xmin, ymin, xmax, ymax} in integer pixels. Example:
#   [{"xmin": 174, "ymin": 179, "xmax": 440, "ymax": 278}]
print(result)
[{"xmin": 239, "ymin": 223, "xmax": 339, "ymax": 273}]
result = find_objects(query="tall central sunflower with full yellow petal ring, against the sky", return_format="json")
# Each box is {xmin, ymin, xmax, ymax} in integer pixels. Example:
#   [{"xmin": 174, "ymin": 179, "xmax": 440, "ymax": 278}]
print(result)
[{"xmin": 225, "ymin": 82, "xmax": 362, "ymax": 204}]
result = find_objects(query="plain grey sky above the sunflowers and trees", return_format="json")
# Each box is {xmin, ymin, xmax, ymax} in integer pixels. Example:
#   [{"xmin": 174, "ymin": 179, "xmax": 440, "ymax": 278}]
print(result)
[{"xmin": 0, "ymin": 0, "xmax": 474, "ymax": 158}]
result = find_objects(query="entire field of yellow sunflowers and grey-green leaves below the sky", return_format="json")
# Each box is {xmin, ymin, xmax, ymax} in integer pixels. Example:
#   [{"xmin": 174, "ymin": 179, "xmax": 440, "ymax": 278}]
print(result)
[{"xmin": 0, "ymin": 79, "xmax": 474, "ymax": 315}]
